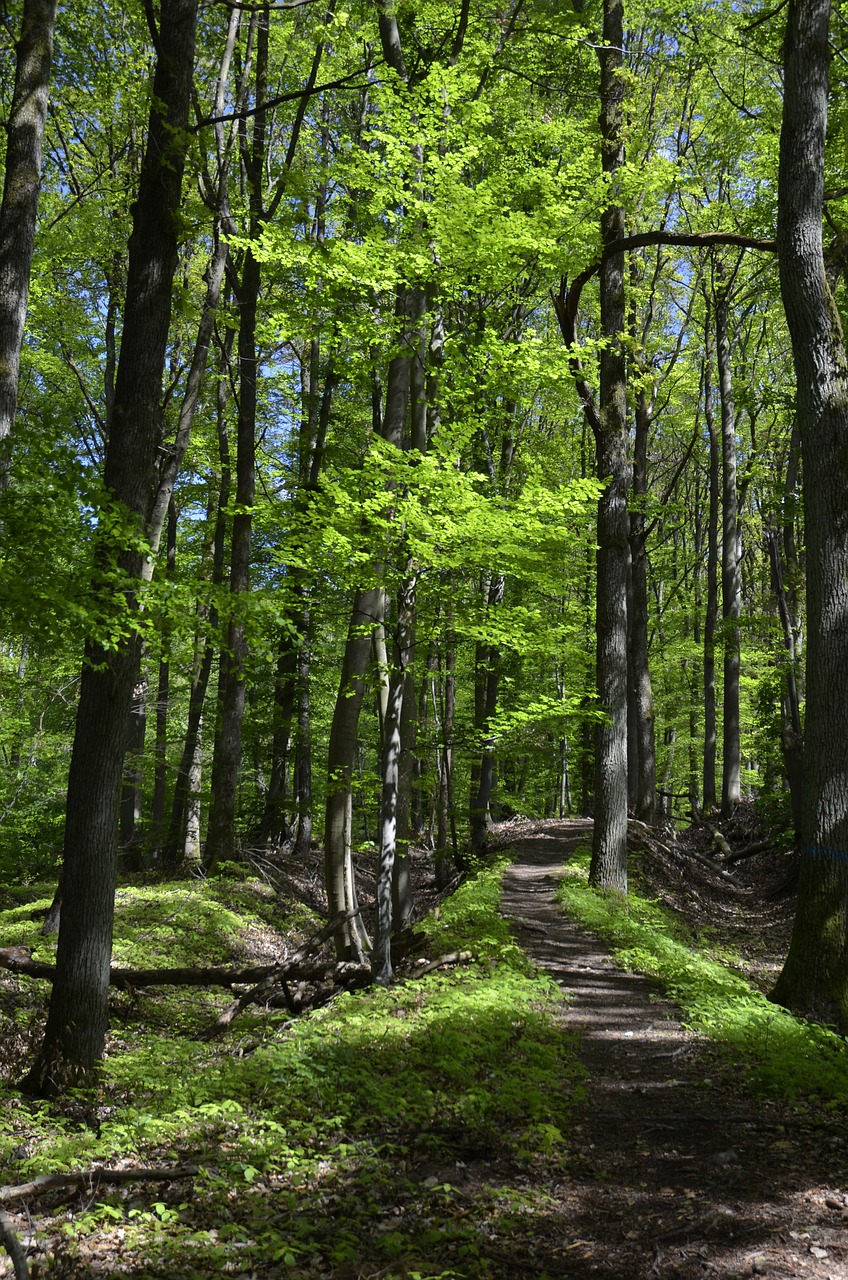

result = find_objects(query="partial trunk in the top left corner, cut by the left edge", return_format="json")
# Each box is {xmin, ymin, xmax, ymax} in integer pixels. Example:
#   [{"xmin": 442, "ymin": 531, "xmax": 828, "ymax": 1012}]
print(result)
[{"xmin": 0, "ymin": 0, "xmax": 56, "ymax": 490}]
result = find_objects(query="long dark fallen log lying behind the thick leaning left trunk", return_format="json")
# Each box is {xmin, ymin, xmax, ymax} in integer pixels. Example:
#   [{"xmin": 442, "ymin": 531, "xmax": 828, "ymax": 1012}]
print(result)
[{"xmin": 0, "ymin": 911, "xmax": 357, "ymax": 988}]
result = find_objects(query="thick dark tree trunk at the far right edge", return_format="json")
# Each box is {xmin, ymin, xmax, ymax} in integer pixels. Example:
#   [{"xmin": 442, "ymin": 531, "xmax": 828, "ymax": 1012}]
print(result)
[{"xmin": 774, "ymin": 0, "xmax": 848, "ymax": 1034}]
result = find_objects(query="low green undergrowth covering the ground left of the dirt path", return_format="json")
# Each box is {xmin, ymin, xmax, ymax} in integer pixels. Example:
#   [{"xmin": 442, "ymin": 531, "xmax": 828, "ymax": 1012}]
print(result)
[{"xmin": 0, "ymin": 869, "xmax": 582, "ymax": 1280}]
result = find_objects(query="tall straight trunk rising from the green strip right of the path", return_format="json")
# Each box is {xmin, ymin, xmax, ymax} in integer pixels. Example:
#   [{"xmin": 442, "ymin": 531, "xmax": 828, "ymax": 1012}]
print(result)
[{"xmin": 589, "ymin": 0, "xmax": 629, "ymax": 893}]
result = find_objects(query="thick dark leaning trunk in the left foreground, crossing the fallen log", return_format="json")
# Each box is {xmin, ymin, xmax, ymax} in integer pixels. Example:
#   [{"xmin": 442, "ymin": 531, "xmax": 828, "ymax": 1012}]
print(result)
[{"xmin": 26, "ymin": 0, "xmax": 196, "ymax": 1093}]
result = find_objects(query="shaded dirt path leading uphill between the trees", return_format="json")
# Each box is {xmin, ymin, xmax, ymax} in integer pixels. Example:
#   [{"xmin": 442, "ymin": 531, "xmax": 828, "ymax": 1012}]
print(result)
[{"xmin": 502, "ymin": 822, "xmax": 848, "ymax": 1280}]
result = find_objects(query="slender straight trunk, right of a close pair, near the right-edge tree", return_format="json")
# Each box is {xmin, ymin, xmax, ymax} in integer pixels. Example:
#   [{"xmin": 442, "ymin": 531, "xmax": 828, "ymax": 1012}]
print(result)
[{"xmin": 716, "ymin": 281, "xmax": 742, "ymax": 818}]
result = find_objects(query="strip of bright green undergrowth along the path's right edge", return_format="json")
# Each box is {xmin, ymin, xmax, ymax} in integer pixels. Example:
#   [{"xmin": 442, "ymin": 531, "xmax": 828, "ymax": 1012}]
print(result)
[{"xmin": 559, "ymin": 850, "xmax": 848, "ymax": 1108}]
